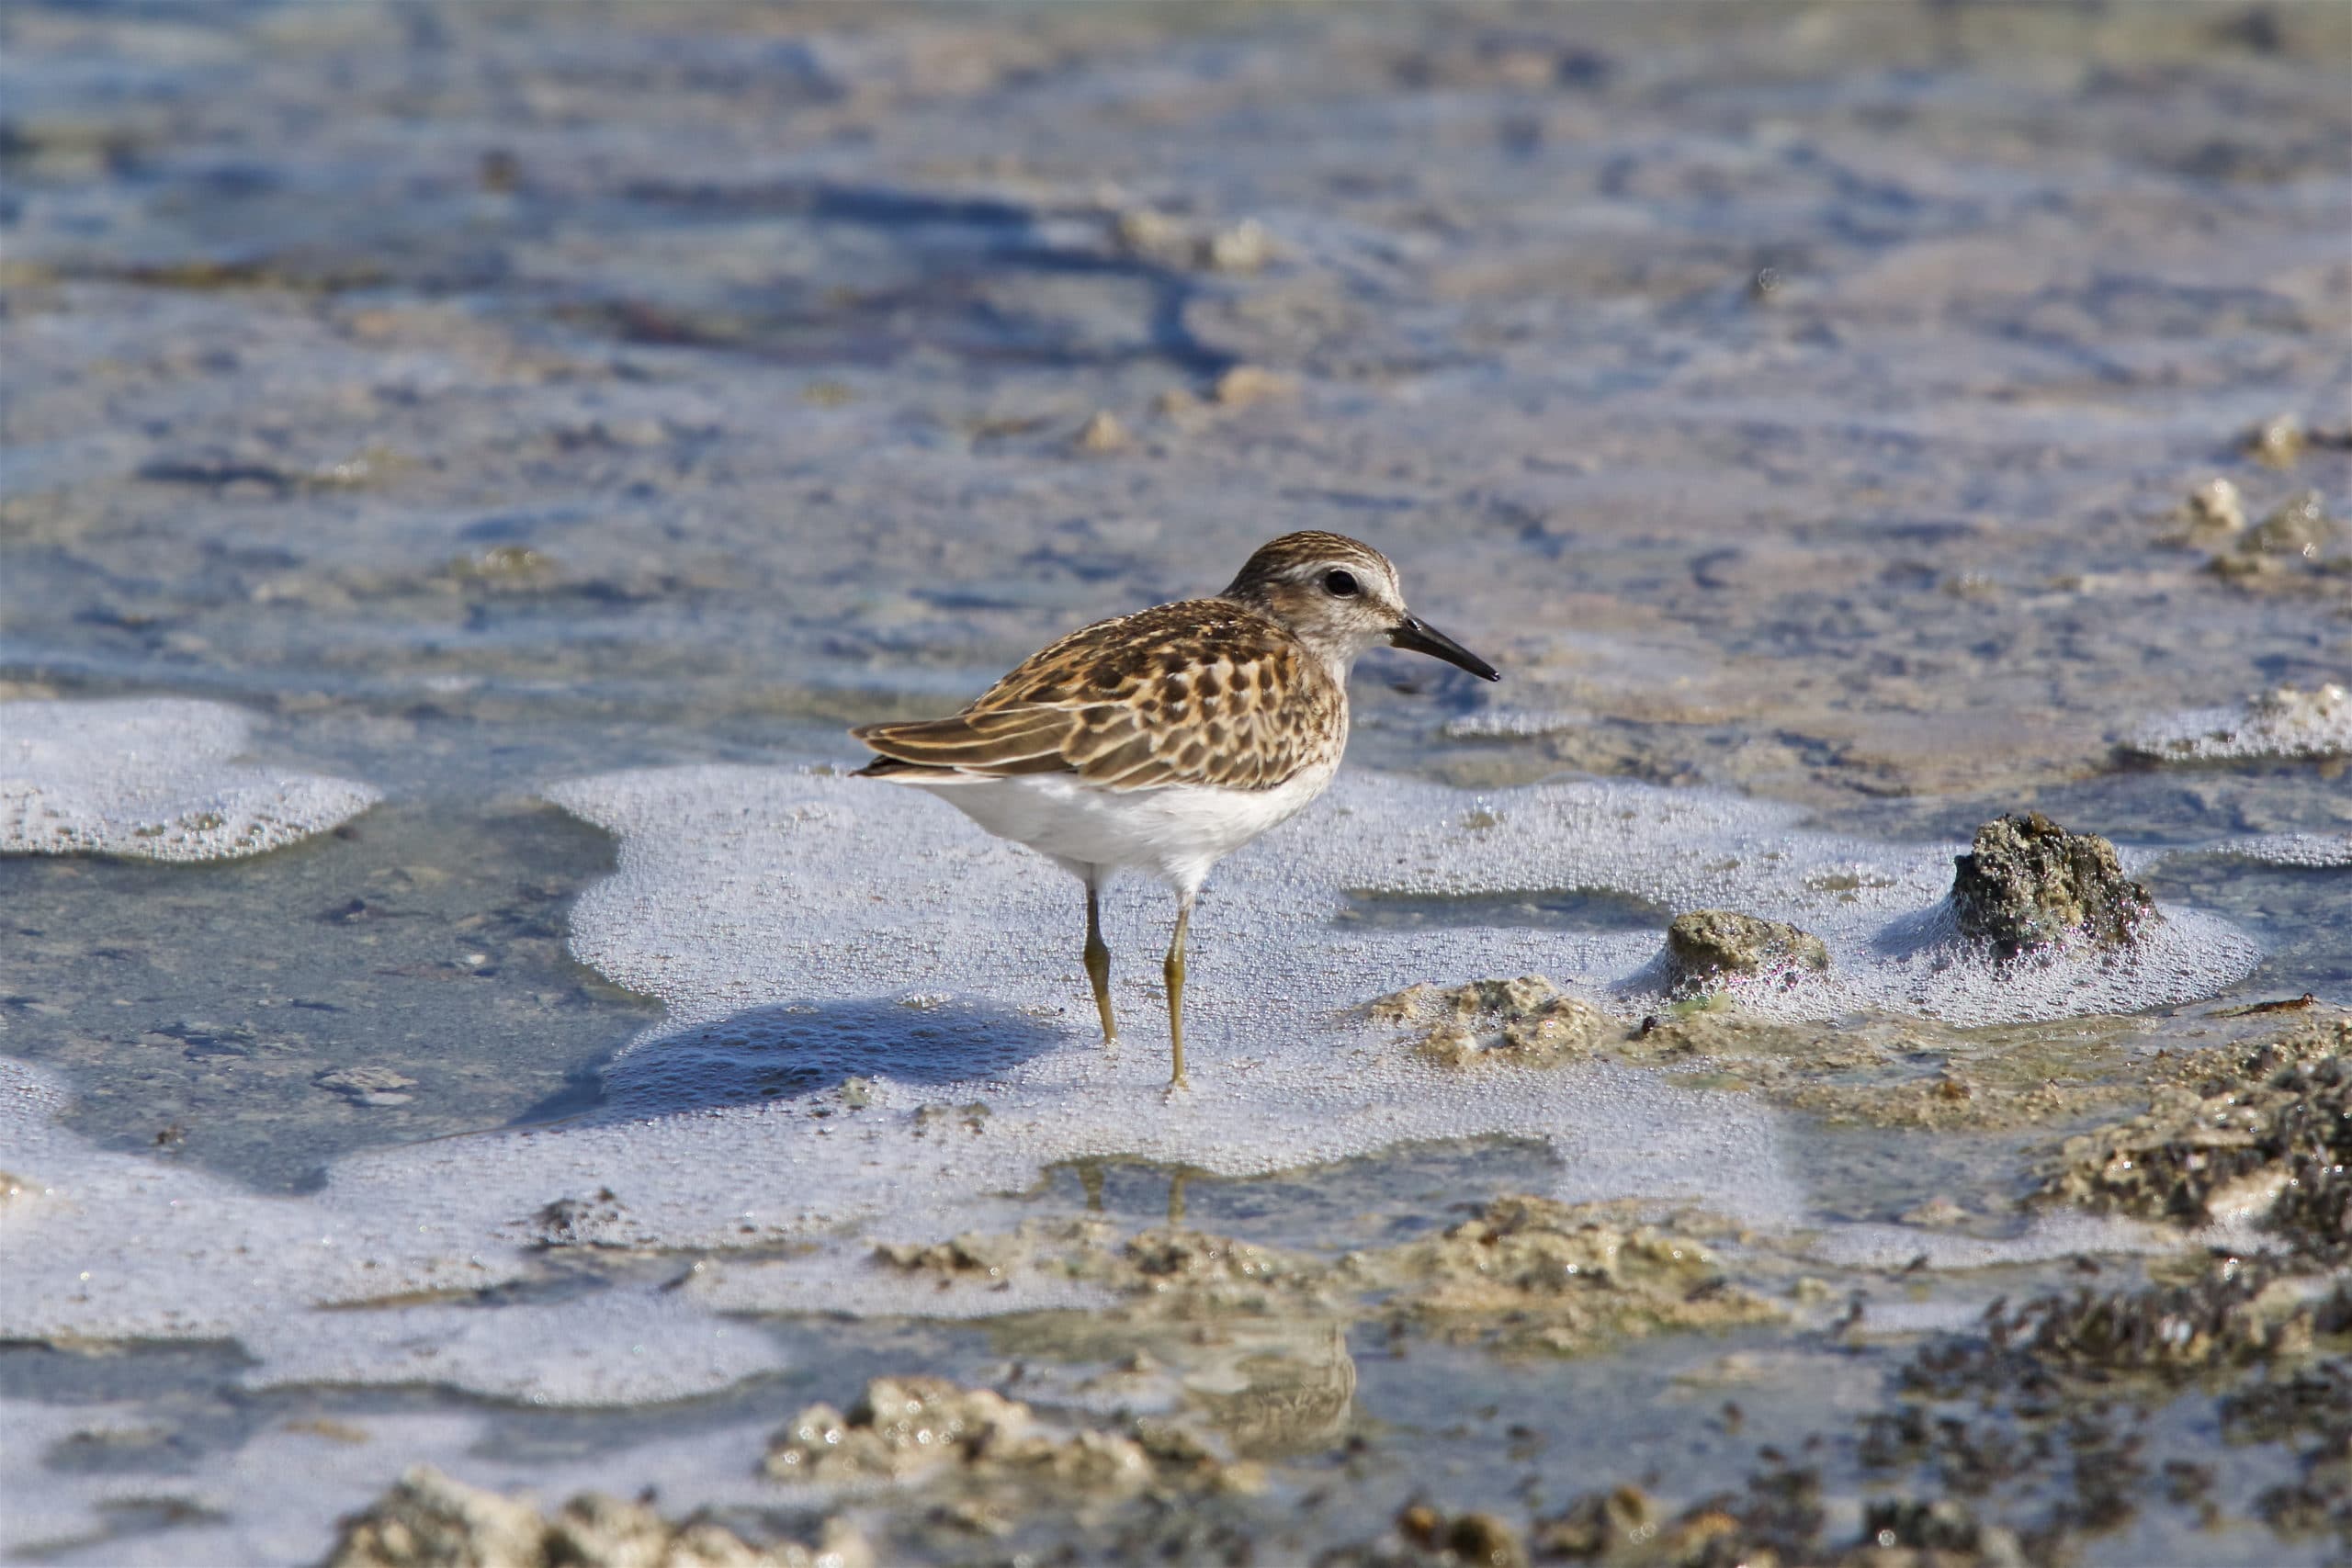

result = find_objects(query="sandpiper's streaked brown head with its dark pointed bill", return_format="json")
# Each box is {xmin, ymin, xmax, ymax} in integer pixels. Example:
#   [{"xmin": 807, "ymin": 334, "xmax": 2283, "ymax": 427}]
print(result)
[{"xmin": 1223, "ymin": 531, "xmax": 1503, "ymax": 680}]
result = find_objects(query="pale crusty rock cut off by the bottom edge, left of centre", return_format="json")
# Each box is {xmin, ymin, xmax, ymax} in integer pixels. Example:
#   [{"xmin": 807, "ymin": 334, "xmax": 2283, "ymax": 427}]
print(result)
[{"xmin": 327, "ymin": 1464, "xmax": 875, "ymax": 1568}]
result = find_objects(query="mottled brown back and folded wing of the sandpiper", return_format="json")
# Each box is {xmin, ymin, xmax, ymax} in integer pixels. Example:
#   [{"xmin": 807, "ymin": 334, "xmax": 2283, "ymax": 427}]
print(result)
[{"xmin": 849, "ymin": 600, "xmax": 1348, "ymax": 790}]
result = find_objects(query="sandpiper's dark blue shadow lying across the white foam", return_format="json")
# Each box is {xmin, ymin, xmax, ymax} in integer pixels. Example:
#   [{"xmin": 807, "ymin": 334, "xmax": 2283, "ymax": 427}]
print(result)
[{"xmin": 513, "ymin": 997, "xmax": 1068, "ymax": 1126}]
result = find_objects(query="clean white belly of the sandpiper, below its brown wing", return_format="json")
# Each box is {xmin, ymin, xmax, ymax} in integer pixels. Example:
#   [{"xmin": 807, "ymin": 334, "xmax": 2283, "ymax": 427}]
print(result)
[{"xmin": 891, "ymin": 760, "xmax": 1339, "ymax": 894}]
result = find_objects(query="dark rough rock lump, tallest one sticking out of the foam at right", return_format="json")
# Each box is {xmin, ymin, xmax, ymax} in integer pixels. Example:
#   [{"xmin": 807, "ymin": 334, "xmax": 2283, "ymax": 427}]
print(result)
[{"xmin": 1952, "ymin": 811, "xmax": 2164, "ymax": 957}]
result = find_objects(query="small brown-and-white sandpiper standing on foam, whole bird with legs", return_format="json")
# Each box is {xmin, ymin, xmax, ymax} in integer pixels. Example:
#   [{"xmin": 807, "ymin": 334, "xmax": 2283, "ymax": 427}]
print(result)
[{"xmin": 849, "ymin": 531, "xmax": 1503, "ymax": 1086}]
